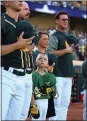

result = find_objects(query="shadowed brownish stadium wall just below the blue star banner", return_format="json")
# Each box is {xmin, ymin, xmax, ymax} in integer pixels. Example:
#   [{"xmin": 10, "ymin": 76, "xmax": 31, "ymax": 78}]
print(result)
[{"xmin": 31, "ymin": 13, "xmax": 87, "ymax": 32}]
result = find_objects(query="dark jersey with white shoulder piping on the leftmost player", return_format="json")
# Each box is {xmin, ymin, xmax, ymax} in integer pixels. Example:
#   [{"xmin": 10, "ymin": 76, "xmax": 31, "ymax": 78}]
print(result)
[{"xmin": 1, "ymin": 14, "xmax": 22, "ymax": 68}]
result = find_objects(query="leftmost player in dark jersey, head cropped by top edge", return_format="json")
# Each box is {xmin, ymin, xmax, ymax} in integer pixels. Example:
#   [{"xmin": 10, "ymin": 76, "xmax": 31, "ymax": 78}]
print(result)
[{"xmin": 1, "ymin": 1, "xmax": 34, "ymax": 120}]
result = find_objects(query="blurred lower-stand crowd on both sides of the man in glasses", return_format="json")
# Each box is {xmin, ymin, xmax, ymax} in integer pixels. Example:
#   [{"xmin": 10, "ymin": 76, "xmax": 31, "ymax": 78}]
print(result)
[{"xmin": 35, "ymin": 25, "xmax": 87, "ymax": 61}]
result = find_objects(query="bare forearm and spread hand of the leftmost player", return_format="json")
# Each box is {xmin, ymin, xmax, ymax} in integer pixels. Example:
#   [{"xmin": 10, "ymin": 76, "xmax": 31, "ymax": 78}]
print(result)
[{"xmin": 1, "ymin": 33, "xmax": 34, "ymax": 55}]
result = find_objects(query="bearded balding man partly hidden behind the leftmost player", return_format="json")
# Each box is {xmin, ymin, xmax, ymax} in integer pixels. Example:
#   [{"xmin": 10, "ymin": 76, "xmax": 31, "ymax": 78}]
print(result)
[{"xmin": 16, "ymin": 2, "xmax": 38, "ymax": 120}]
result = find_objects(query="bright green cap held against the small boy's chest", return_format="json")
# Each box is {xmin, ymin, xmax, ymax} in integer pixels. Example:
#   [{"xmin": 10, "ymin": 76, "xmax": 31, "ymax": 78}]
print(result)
[{"xmin": 39, "ymin": 73, "xmax": 56, "ymax": 87}]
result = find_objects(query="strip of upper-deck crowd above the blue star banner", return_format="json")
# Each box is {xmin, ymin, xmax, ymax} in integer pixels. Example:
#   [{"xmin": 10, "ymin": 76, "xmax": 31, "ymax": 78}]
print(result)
[{"xmin": 32, "ymin": 0, "xmax": 87, "ymax": 11}]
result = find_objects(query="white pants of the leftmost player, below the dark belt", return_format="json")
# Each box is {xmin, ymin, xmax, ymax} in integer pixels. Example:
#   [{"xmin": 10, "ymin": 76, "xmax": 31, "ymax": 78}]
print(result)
[{"xmin": 1, "ymin": 67, "xmax": 32, "ymax": 120}]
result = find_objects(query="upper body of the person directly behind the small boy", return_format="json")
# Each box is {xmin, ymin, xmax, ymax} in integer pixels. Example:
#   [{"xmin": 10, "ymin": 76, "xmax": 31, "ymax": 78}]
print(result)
[{"xmin": 33, "ymin": 31, "xmax": 56, "ymax": 72}]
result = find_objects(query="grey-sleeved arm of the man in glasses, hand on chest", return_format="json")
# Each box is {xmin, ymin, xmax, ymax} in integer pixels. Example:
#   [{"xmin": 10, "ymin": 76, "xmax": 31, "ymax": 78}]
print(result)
[{"xmin": 48, "ymin": 35, "xmax": 73, "ymax": 56}]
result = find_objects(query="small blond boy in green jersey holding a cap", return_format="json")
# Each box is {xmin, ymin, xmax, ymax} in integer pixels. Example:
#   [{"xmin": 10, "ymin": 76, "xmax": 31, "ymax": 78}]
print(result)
[{"xmin": 32, "ymin": 53, "xmax": 56, "ymax": 120}]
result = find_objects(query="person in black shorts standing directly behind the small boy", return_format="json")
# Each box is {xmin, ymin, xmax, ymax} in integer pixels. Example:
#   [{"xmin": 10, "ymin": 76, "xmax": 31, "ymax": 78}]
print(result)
[{"xmin": 33, "ymin": 32, "xmax": 57, "ymax": 118}]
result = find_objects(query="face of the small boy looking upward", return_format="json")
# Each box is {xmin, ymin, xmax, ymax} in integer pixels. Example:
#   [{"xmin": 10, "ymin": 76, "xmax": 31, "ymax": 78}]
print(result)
[{"xmin": 36, "ymin": 54, "xmax": 48, "ymax": 68}]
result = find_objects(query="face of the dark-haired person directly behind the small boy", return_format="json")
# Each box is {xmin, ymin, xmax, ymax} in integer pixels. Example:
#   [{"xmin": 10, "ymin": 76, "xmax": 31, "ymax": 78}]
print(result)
[{"xmin": 38, "ymin": 34, "xmax": 48, "ymax": 48}]
